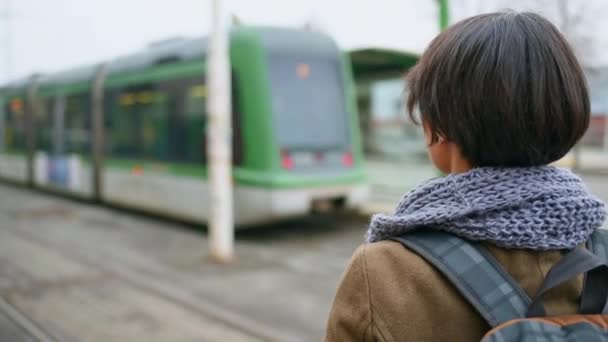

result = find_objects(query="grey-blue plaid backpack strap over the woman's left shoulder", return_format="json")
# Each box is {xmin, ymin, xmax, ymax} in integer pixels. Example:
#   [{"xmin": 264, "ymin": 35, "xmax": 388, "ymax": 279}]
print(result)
[{"xmin": 392, "ymin": 231, "xmax": 531, "ymax": 327}]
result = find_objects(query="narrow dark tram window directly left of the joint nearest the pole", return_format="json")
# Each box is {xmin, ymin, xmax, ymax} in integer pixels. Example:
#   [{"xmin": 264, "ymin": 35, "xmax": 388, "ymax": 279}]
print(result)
[{"xmin": 63, "ymin": 93, "xmax": 91, "ymax": 154}]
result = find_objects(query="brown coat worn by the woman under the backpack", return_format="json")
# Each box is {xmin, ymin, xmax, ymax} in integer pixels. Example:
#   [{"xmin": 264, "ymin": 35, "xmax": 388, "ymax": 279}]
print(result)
[{"xmin": 326, "ymin": 241, "xmax": 582, "ymax": 342}]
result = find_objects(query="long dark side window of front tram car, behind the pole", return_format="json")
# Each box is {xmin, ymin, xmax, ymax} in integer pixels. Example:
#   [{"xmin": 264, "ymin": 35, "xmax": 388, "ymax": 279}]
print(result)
[{"xmin": 105, "ymin": 78, "xmax": 243, "ymax": 165}]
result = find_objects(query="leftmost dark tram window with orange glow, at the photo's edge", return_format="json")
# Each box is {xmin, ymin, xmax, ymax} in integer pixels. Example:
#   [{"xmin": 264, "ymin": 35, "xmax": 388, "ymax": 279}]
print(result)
[{"xmin": 4, "ymin": 97, "xmax": 25, "ymax": 152}]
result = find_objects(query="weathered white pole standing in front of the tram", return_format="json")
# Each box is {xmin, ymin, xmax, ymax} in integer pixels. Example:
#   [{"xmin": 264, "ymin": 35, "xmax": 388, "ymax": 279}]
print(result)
[{"xmin": 207, "ymin": 0, "xmax": 234, "ymax": 263}]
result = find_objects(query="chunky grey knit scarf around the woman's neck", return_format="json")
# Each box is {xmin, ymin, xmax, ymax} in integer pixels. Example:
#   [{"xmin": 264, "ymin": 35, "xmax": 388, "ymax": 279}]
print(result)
[{"xmin": 366, "ymin": 166, "xmax": 606, "ymax": 250}]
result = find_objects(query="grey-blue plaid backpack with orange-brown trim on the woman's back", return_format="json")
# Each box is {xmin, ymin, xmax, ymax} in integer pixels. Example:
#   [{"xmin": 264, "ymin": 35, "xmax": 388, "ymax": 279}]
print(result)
[{"xmin": 393, "ymin": 230, "xmax": 608, "ymax": 342}]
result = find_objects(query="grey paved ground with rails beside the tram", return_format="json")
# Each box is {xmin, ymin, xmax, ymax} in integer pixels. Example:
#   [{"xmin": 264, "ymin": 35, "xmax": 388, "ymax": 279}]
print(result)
[{"xmin": 0, "ymin": 162, "xmax": 608, "ymax": 342}]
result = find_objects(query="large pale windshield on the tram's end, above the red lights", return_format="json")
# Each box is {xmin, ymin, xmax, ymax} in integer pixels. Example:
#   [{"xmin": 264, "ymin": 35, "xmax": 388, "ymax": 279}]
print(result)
[{"xmin": 269, "ymin": 56, "xmax": 348, "ymax": 150}]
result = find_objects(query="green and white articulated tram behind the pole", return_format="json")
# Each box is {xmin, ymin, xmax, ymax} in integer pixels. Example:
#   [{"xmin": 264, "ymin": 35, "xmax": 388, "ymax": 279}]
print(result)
[{"xmin": 0, "ymin": 27, "xmax": 368, "ymax": 225}]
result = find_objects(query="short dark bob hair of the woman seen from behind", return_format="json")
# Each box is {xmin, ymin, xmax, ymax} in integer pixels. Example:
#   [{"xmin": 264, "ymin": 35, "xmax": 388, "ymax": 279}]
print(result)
[{"xmin": 407, "ymin": 11, "xmax": 590, "ymax": 167}]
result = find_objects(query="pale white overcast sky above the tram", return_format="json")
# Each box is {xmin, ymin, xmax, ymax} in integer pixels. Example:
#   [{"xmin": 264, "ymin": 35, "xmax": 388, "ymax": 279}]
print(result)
[{"xmin": 0, "ymin": 0, "xmax": 608, "ymax": 81}]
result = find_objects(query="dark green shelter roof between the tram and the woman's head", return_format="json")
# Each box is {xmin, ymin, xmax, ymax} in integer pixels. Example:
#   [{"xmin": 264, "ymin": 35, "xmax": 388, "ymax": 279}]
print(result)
[{"xmin": 349, "ymin": 48, "xmax": 420, "ymax": 80}]
